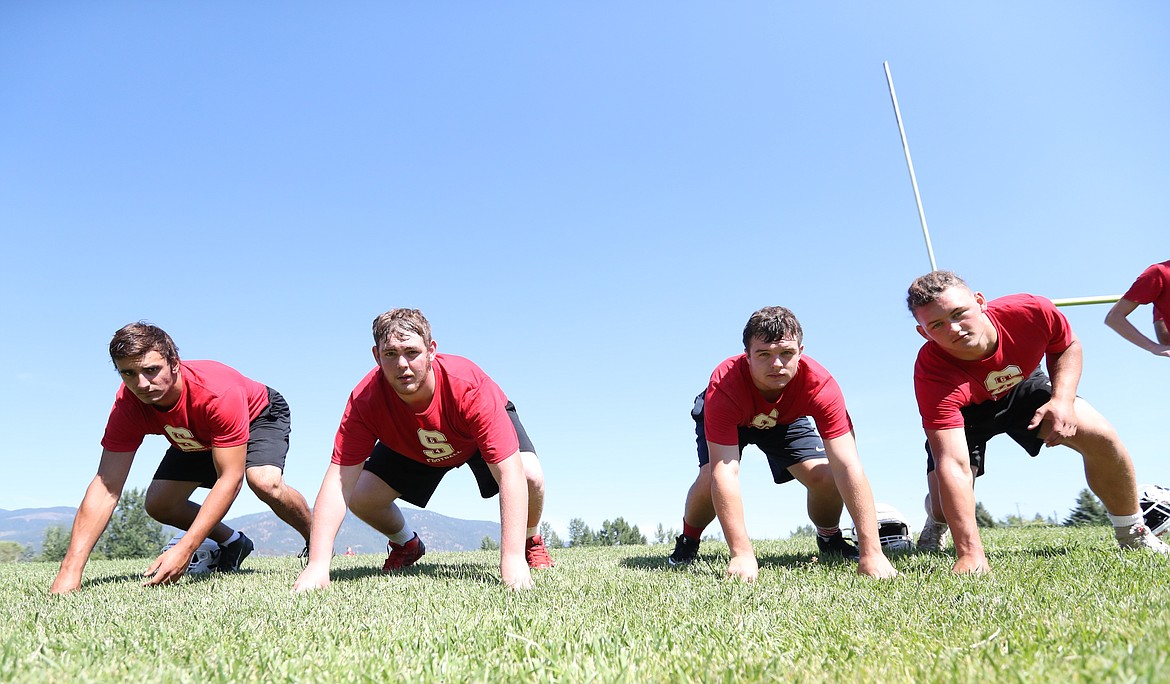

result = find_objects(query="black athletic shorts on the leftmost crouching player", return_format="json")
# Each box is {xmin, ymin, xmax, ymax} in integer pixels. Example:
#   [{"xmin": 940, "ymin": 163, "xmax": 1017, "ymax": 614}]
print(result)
[{"xmin": 154, "ymin": 387, "xmax": 293, "ymax": 489}]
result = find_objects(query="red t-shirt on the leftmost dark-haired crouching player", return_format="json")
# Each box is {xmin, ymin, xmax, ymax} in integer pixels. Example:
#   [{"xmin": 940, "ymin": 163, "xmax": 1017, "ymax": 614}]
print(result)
[{"xmin": 102, "ymin": 361, "xmax": 268, "ymax": 451}]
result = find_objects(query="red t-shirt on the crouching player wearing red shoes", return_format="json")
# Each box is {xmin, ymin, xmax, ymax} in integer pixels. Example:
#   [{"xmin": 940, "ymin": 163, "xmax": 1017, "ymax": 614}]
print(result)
[{"xmin": 333, "ymin": 354, "xmax": 519, "ymax": 468}]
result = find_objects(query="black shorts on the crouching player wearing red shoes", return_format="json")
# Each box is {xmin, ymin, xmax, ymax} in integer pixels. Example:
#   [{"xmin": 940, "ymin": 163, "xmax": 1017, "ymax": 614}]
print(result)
[{"xmin": 365, "ymin": 401, "xmax": 536, "ymax": 509}]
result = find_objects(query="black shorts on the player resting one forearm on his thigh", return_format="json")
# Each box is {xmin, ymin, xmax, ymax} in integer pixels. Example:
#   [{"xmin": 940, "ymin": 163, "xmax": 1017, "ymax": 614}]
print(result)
[{"xmin": 927, "ymin": 368, "xmax": 1052, "ymax": 477}]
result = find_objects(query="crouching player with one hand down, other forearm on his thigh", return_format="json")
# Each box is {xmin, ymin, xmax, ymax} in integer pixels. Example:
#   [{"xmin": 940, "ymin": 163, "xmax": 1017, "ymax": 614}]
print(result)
[{"xmin": 907, "ymin": 271, "xmax": 1170, "ymax": 574}]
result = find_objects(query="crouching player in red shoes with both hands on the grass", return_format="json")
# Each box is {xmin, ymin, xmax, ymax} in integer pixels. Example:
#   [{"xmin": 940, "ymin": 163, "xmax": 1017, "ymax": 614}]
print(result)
[{"xmin": 293, "ymin": 309, "xmax": 552, "ymax": 592}]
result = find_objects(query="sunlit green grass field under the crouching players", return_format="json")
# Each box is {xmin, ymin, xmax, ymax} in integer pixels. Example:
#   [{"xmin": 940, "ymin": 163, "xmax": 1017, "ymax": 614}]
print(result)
[{"xmin": 0, "ymin": 527, "xmax": 1170, "ymax": 683}]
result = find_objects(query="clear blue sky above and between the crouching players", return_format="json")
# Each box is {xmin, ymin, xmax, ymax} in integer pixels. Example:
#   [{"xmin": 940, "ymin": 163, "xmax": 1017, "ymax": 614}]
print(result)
[{"xmin": 0, "ymin": 1, "xmax": 1170, "ymax": 538}]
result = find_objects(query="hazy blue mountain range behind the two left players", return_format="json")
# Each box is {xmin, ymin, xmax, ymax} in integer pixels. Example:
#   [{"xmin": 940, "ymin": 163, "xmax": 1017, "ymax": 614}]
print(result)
[{"xmin": 0, "ymin": 506, "xmax": 500, "ymax": 555}]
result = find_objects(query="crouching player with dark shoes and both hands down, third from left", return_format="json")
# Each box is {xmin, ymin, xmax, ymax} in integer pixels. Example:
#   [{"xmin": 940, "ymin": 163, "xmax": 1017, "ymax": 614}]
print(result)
[{"xmin": 669, "ymin": 306, "xmax": 896, "ymax": 581}]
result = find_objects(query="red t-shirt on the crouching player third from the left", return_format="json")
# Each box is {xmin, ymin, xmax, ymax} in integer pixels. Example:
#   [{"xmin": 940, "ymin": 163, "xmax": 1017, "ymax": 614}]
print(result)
[{"xmin": 703, "ymin": 354, "xmax": 853, "ymax": 445}]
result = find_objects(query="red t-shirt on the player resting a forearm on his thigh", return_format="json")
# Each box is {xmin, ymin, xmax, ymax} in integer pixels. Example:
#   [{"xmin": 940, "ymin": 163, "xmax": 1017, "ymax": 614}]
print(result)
[{"xmin": 914, "ymin": 295, "xmax": 1074, "ymax": 430}]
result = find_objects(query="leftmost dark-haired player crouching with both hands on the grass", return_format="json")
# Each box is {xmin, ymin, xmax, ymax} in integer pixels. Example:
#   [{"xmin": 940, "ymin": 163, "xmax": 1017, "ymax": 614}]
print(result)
[{"xmin": 50, "ymin": 323, "xmax": 310, "ymax": 594}]
